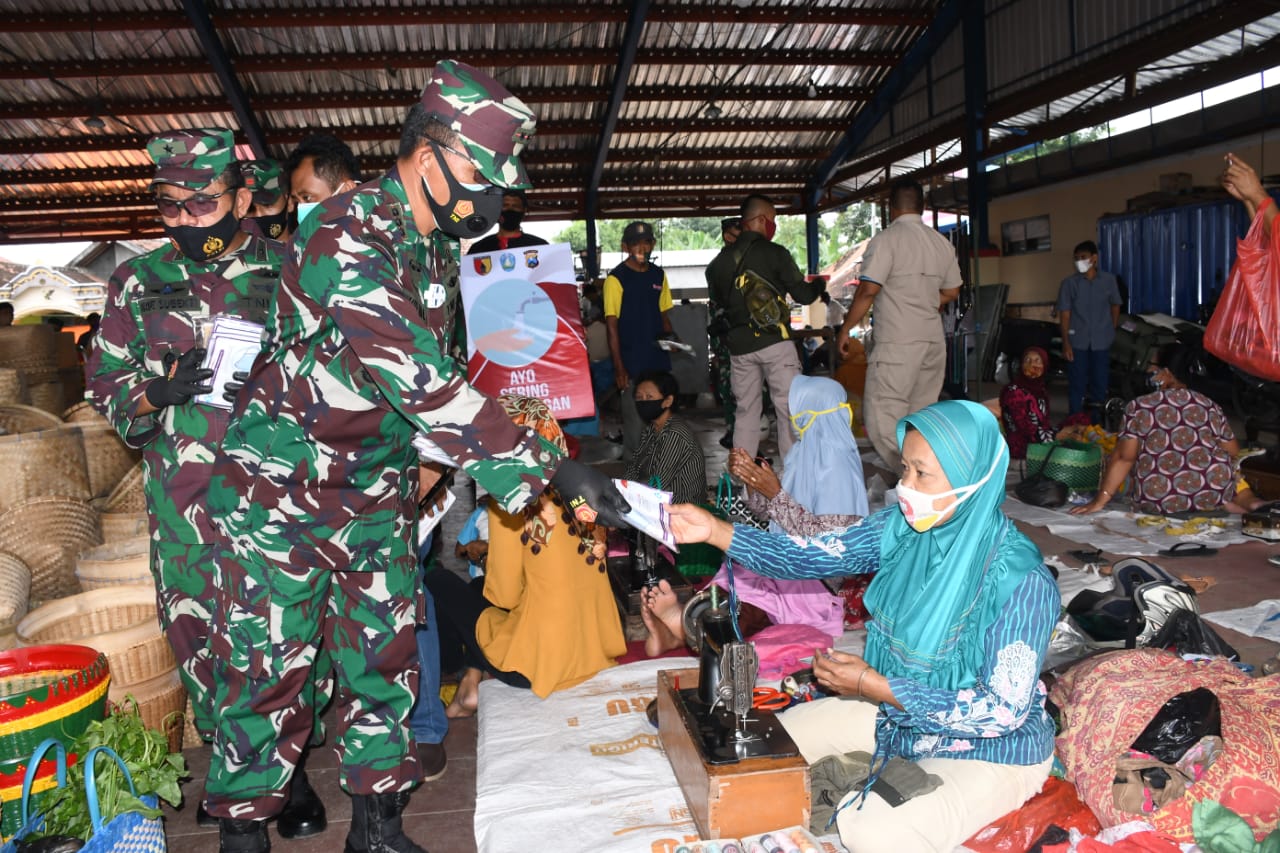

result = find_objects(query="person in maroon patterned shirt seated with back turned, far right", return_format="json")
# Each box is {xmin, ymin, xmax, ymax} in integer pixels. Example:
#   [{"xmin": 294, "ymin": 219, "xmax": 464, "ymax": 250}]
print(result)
[{"xmin": 1071, "ymin": 343, "xmax": 1263, "ymax": 515}]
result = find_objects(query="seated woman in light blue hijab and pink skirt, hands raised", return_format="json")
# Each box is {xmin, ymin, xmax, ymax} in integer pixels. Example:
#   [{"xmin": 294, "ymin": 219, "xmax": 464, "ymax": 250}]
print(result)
[{"xmin": 640, "ymin": 375, "xmax": 868, "ymax": 656}]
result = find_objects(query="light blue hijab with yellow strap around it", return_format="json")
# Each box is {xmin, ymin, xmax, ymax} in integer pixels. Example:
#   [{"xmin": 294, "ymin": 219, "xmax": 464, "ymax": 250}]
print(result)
[{"xmin": 769, "ymin": 375, "xmax": 869, "ymax": 533}]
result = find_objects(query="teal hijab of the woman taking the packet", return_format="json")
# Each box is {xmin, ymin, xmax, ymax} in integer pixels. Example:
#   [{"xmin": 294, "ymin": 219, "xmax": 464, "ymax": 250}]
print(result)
[{"xmin": 864, "ymin": 400, "xmax": 1043, "ymax": 690}]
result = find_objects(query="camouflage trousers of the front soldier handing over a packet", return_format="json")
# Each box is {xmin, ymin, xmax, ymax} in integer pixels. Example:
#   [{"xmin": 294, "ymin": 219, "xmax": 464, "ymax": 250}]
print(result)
[{"xmin": 205, "ymin": 547, "xmax": 422, "ymax": 818}]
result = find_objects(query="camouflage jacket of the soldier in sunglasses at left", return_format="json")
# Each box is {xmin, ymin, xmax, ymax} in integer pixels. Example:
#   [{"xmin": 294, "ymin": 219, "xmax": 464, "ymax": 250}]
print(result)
[{"xmin": 86, "ymin": 230, "xmax": 284, "ymax": 544}]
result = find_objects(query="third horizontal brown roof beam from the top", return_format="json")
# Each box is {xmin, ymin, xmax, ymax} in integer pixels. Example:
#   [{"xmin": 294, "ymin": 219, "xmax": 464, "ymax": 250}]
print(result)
[{"xmin": 0, "ymin": 86, "xmax": 873, "ymax": 120}]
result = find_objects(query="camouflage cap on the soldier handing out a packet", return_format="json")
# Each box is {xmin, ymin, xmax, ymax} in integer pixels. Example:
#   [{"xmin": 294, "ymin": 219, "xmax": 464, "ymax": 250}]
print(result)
[{"xmin": 421, "ymin": 59, "xmax": 538, "ymax": 188}]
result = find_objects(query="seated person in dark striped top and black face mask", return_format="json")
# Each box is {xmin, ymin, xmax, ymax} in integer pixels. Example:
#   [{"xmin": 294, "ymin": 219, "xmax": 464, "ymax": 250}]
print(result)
[{"xmin": 623, "ymin": 370, "xmax": 707, "ymax": 503}]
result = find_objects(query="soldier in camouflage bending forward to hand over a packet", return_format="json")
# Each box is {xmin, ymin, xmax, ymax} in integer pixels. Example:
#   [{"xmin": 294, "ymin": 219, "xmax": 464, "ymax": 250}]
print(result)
[{"xmin": 206, "ymin": 61, "xmax": 626, "ymax": 853}]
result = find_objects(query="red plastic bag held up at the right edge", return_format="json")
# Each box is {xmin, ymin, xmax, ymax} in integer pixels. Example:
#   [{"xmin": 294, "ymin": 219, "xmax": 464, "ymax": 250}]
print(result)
[{"xmin": 1204, "ymin": 200, "xmax": 1280, "ymax": 382}]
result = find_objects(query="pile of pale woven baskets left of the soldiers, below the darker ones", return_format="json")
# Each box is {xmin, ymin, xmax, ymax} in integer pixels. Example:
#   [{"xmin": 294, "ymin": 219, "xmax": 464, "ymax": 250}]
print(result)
[{"xmin": 0, "ymin": 403, "xmax": 187, "ymax": 749}]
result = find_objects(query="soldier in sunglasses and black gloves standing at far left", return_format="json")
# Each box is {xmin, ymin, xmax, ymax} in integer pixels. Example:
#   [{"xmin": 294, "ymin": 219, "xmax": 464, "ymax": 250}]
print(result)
[{"xmin": 87, "ymin": 128, "xmax": 319, "ymax": 829}]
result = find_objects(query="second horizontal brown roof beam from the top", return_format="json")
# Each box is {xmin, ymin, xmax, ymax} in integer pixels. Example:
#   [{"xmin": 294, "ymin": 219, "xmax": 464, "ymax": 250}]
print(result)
[{"xmin": 0, "ymin": 47, "xmax": 902, "ymax": 79}]
